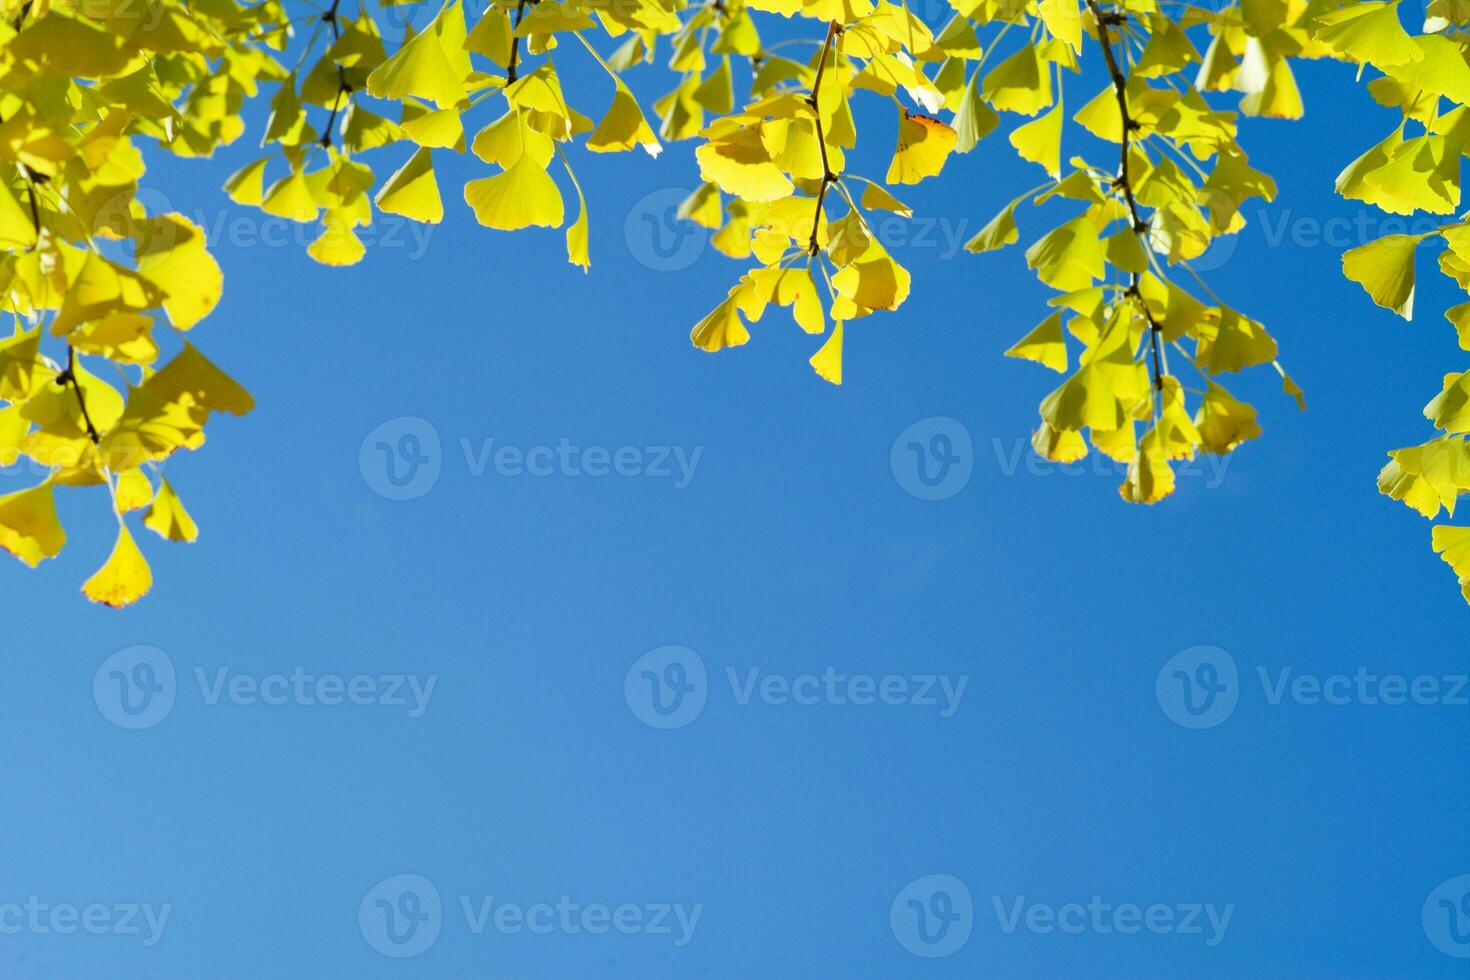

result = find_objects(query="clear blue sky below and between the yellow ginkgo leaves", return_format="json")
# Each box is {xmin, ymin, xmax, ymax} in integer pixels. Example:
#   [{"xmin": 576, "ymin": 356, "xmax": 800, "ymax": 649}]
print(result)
[{"xmin": 0, "ymin": 15, "xmax": 1470, "ymax": 980}]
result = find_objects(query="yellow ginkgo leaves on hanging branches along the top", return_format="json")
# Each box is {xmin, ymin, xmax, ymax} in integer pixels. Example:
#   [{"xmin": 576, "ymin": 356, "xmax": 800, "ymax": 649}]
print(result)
[{"xmin": 0, "ymin": 0, "xmax": 1470, "ymax": 605}]
